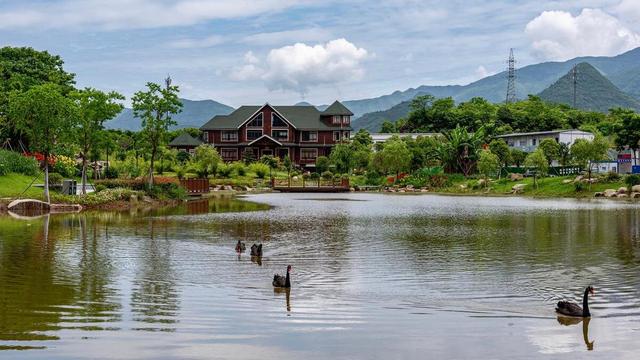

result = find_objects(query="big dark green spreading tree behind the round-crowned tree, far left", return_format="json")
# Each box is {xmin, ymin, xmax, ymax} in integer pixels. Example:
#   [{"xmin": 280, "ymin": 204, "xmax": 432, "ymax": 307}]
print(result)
[{"xmin": 0, "ymin": 46, "xmax": 75, "ymax": 140}]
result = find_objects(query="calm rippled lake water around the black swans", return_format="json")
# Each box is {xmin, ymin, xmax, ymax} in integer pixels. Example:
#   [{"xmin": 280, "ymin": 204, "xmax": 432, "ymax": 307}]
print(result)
[{"xmin": 0, "ymin": 194, "xmax": 640, "ymax": 360}]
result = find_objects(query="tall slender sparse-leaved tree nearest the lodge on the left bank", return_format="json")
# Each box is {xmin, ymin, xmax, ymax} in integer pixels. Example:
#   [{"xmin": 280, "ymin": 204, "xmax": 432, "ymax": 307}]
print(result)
[{"xmin": 132, "ymin": 82, "xmax": 182, "ymax": 187}]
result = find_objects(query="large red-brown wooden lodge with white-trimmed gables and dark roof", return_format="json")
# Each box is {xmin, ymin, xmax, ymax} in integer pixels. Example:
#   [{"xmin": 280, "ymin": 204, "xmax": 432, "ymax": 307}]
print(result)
[{"xmin": 200, "ymin": 101, "xmax": 353, "ymax": 167}]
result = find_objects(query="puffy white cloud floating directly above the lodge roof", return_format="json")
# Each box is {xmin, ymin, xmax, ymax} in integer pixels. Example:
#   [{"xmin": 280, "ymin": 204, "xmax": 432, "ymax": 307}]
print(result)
[{"xmin": 230, "ymin": 39, "xmax": 369, "ymax": 97}]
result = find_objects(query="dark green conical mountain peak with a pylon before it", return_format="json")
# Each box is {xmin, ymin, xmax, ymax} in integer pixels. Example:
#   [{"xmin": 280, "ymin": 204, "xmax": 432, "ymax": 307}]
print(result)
[{"xmin": 539, "ymin": 62, "xmax": 640, "ymax": 112}]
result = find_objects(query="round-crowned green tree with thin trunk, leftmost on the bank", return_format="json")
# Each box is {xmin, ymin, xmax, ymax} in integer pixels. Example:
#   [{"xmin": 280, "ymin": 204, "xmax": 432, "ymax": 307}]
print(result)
[{"xmin": 9, "ymin": 84, "xmax": 78, "ymax": 202}]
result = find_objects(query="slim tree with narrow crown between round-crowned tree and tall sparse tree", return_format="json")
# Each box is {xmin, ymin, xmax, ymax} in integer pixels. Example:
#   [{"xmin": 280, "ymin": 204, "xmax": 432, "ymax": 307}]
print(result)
[{"xmin": 70, "ymin": 88, "xmax": 124, "ymax": 195}]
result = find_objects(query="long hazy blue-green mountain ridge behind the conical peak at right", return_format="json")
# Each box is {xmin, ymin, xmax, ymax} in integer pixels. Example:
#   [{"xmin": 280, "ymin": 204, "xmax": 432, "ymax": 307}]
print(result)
[{"xmin": 343, "ymin": 48, "xmax": 640, "ymax": 128}]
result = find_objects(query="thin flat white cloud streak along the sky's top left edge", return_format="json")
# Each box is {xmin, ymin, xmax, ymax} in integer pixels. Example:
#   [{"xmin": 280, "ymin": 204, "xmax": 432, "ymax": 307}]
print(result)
[{"xmin": 0, "ymin": 0, "xmax": 303, "ymax": 29}]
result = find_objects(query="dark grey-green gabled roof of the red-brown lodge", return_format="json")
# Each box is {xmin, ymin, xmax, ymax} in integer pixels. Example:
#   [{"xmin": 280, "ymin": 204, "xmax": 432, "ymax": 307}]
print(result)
[{"xmin": 200, "ymin": 101, "xmax": 353, "ymax": 130}]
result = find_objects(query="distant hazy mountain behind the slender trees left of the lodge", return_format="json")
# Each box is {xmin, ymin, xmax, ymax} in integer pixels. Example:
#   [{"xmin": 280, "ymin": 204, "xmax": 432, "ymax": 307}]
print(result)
[{"xmin": 105, "ymin": 99, "xmax": 233, "ymax": 130}]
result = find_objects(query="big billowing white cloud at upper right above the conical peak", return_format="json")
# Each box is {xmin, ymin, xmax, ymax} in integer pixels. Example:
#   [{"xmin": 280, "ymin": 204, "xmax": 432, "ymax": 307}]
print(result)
[{"xmin": 525, "ymin": 9, "xmax": 640, "ymax": 60}]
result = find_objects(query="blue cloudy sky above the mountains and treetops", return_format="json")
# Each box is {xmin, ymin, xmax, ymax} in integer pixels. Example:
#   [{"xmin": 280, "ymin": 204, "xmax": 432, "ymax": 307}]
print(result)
[{"xmin": 0, "ymin": 0, "xmax": 640, "ymax": 106}]
